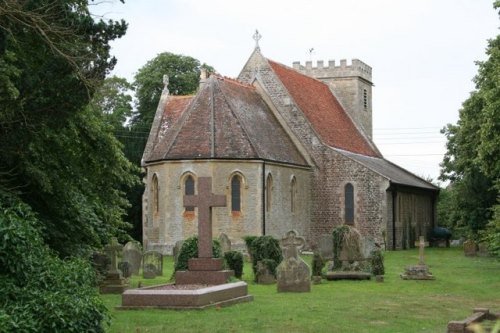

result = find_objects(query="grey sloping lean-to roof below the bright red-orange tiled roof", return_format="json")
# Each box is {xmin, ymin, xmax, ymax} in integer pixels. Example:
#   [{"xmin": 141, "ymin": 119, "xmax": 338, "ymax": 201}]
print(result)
[{"xmin": 339, "ymin": 151, "xmax": 439, "ymax": 191}]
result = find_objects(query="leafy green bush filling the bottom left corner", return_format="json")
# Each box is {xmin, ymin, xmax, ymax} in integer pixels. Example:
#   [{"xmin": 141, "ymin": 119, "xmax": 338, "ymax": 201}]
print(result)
[{"xmin": 0, "ymin": 194, "xmax": 109, "ymax": 332}]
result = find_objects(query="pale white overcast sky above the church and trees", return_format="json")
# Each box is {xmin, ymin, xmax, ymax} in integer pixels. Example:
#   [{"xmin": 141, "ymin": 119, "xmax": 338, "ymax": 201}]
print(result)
[{"xmin": 91, "ymin": 0, "xmax": 500, "ymax": 184}]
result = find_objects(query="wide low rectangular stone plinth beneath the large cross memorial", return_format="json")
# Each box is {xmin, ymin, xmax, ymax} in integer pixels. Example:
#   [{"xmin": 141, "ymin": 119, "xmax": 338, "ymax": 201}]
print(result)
[{"xmin": 118, "ymin": 281, "xmax": 253, "ymax": 310}]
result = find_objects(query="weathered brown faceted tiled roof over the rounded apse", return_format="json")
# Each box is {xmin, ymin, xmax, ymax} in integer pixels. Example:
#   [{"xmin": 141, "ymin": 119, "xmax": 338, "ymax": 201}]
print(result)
[{"xmin": 146, "ymin": 76, "xmax": 307, "ymax": 166}]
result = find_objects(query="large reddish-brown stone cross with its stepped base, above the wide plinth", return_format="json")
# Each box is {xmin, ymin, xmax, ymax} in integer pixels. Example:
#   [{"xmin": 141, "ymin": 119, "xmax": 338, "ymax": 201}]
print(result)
[{"xmin": 175, "ymin": 177, "xmax": 234, "ymax": 285}]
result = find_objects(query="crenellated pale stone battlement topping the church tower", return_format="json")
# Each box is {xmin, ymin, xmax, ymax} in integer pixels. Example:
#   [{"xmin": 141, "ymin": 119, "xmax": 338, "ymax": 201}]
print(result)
[{"xmin": 293, "ymin": 59, "xmax": 372, "ymax": 83}]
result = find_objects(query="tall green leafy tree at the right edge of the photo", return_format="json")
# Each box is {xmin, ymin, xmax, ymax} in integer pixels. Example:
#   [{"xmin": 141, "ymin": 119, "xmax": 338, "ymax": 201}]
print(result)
[{"xmin": 440, "ymin": 1, "xmax": 500, "ymax": 249}]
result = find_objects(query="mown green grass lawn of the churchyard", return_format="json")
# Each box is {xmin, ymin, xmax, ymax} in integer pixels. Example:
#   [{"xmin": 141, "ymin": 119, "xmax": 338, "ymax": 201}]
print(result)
[{"xmin": 102, "ymin": 248, "xmax": 500, "ymax": 333}]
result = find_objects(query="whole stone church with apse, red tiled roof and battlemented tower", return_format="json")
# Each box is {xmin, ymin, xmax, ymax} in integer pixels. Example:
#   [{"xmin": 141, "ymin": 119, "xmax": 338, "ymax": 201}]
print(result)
[{"xmin": 142, "ymin": 38, "xmax": 439, "ymax": 253}]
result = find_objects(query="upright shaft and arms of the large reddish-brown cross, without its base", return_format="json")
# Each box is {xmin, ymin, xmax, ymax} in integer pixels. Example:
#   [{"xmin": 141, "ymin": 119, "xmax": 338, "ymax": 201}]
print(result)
[{"xmin": 184, "ymin": 177, "xmax": 226, "ymax": 258}]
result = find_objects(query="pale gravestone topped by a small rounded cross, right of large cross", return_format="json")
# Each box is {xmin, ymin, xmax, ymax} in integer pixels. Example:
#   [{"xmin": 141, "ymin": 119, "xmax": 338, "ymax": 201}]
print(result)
[{"xmin": 276, "ymin": 230, "xmax": 311, "ymax": 292}]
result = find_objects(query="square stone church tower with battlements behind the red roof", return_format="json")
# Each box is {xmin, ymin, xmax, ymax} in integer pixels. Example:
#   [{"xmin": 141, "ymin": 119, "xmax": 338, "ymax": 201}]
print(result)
[{"xmin": 293, "ymin": 59, "xmax": 373, "ymax": 139}]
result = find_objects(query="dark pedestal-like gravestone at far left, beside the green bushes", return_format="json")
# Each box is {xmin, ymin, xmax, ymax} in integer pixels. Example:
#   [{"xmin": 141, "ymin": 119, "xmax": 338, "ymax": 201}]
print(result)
[{"xmin": 99, "ymin": 238, "xmax": 128, "ymax": 294}]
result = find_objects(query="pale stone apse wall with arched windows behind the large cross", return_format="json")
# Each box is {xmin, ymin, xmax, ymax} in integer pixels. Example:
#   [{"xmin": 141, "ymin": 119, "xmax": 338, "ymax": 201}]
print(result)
[{"xmin": 143, "ymin": 160, "xmax": 310, "ymax": 254}]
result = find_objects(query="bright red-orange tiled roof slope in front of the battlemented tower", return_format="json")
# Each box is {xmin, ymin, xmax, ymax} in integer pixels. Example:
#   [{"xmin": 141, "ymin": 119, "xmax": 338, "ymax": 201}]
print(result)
[{"xmin": 267, "ymin": 59, "xmax": 380, "ymax": 157}]
